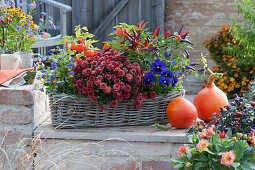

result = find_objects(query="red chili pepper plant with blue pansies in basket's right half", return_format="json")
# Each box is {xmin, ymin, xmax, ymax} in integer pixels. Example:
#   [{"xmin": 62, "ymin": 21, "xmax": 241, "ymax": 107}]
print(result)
[{"xmin": 104, "ymin": 21, "xmax": 200, "ymax": 94}]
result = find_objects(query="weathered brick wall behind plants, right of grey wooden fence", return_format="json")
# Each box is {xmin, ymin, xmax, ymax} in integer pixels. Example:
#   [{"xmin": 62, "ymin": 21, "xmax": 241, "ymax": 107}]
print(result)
[{"xmin": 165, "ymin": 0, "xmax": 238, "ymax": 65}]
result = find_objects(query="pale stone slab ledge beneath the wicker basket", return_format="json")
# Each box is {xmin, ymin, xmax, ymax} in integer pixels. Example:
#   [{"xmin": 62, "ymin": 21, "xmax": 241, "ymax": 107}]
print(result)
[{"xmin": 34, "ymin": 121, "xmax": 188, "ymax": 143}]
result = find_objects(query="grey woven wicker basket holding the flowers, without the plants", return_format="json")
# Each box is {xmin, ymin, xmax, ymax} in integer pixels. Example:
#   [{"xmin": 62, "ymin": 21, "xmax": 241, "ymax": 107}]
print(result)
[{"xmin": 49, "ymin": 91, "xmax": 185, "ymax": 128}]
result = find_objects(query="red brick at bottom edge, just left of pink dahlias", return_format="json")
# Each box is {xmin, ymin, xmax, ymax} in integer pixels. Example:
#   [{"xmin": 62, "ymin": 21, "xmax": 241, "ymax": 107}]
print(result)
[{"xmin": 142, "ymin": 161, "xmax": 174, "ymax": 170}]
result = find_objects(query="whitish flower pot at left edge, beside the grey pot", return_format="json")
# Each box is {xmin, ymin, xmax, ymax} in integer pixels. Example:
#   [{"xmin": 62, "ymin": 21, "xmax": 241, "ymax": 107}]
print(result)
[{"xmin": 1, "ymin": 54, "xmax": 22, "ymax": 70}]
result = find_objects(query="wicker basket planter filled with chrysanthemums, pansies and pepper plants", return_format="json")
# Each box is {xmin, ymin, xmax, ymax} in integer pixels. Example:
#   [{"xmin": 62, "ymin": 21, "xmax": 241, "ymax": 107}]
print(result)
[{"xmin": 38, "ymin": 23, "xmax": 198, "ymax": 127}]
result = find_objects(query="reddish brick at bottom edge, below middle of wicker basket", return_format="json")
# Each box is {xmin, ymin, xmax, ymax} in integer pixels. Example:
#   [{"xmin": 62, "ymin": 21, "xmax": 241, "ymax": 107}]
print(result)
[{"xmin": 101, "ymin": 161, "xmax": 139, "ymax": 170}]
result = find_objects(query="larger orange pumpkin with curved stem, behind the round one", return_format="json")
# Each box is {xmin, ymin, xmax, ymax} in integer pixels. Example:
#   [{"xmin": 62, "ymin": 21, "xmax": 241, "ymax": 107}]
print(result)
[{"xmin": 193, "ymin": 72, "xmax": 228, "ymax": 121}]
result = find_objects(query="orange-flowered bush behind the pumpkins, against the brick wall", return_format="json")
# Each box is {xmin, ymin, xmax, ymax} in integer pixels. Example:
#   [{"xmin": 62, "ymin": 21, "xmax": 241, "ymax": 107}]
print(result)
[{"xmin": 204, "ymin": 25, "xmax": 255, "ymax": 97}]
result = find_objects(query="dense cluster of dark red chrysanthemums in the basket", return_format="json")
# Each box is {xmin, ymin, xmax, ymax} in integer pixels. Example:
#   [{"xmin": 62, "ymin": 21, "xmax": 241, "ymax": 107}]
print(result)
[{"xmin": 73, "ymin": 48, "xmax": 156, "ymax": 109}]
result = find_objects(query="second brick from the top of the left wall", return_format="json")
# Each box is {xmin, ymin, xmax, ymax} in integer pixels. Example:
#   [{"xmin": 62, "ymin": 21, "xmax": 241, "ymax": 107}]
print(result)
[{"xmin": 0, "ymin": 106, "xmax": 33, "ymax": 124}]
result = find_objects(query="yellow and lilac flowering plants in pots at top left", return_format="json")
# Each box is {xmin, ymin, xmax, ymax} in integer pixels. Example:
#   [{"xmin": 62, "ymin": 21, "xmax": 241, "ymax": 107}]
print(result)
[{"xmin": 0, "ymin": 0, "xmax": 55, "ymax": 53}]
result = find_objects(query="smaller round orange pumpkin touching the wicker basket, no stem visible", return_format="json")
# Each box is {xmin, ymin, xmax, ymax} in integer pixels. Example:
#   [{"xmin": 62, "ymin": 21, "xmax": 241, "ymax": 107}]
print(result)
[{"xmin": 166, "ymin": 97, "xmax": 197, "ymax": 128}]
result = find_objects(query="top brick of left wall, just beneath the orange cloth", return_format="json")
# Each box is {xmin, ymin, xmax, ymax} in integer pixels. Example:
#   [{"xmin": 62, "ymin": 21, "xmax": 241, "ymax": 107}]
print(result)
[{"xmin": 0, "ymin": 88, "xmax": 34, "ymax": 105}]
